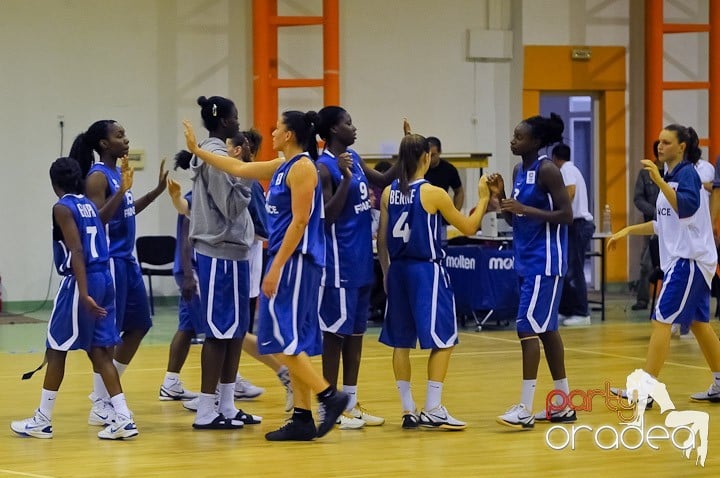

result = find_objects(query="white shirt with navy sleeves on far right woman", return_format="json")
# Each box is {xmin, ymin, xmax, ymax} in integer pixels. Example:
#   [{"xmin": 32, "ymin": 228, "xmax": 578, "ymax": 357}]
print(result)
[{"xmin": 653, "ymin": 161, "xmax": 717, "ymax": 286}]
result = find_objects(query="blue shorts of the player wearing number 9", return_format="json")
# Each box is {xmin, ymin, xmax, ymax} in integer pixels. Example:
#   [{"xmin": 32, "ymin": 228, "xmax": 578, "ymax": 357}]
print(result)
[{"xmin": 320, "ymin": 286, "xmax": 372, "ymax": 335}]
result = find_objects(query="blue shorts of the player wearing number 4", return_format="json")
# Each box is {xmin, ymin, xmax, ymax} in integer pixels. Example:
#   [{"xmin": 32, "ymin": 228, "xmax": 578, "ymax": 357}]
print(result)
[{"xmin": 380, "ymin": 260, "xmax": 458, "ymax": 349}]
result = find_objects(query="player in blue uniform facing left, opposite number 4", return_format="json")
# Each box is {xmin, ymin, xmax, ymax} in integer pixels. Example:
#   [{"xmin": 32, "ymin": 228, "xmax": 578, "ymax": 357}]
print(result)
[{"xmin": 490, "ymin": 113, "xmax": 576, "ymax": 430}]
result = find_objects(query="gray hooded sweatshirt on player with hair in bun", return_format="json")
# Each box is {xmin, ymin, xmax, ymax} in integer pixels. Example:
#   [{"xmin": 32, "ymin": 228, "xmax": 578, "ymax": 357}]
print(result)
[{"xmin": 190, "ymin": 138, "xmax": 255, "ymax": 261}]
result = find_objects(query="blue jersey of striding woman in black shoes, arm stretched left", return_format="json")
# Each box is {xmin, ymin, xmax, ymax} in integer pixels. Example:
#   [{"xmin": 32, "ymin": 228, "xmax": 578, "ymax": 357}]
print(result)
[{"xmin": 265, "ymin": 153, "xmax": 325, "ymax": 267}]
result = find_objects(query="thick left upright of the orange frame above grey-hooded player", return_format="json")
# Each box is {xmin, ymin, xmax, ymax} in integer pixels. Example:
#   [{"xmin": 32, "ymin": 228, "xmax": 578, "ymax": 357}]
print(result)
[{"xmin": 252, "ymin": 0, "xmax": 277, "ymax": 160}]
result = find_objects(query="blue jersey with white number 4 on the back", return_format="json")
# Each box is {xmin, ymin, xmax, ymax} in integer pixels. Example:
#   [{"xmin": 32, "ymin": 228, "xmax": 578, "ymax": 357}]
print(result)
[{"xmin": 387, "ymin": 179, "xmax": 445, "ymax": 261}]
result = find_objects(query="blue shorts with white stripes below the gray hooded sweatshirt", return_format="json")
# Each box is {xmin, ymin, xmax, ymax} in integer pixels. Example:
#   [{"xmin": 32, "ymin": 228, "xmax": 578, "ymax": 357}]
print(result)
[{"xmin": 195, "ymin": 251, "xmax": 250, "ymax": 339}]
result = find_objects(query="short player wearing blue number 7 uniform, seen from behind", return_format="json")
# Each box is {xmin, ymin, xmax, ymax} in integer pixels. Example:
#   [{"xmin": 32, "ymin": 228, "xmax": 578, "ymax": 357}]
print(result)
[{"xmin": 10, "ymin": 158, "xmax": 138, "ymax": 440}]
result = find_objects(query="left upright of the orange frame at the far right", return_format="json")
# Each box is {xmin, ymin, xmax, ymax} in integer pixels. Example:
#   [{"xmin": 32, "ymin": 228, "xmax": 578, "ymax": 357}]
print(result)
[{"xmin": 645, "ymin": 0, "xmax": 664, "ymax": 158}]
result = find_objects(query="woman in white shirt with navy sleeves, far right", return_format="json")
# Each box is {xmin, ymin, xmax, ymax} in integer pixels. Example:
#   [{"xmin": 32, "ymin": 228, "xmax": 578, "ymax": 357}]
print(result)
[{"xmin": 608, "ymin": 124, "xmax": 720, "ymax": 402}]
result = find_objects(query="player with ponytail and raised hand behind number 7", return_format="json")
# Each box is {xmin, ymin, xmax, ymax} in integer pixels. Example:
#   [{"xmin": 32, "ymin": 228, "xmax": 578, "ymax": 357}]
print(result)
[{"xmin": 70, "ymin": 120, "xmax": 167, "ymax": 425}]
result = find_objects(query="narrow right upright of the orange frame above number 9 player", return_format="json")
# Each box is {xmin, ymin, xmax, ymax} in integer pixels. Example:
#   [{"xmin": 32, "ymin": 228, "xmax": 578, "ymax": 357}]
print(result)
[{"xmin": 323, "ymin": 0, "xmax": 340, "ymax": 105}]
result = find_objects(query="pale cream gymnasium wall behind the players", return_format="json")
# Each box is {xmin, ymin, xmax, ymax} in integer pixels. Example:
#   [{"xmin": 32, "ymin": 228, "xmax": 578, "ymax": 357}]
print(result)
[{"xmin": 0, "ymin": 0, "xmax": 707, "ymax": 301}]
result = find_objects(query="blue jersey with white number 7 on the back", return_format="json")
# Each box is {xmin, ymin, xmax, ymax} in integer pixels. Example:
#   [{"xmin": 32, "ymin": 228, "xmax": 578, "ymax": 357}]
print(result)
[{"xmin": 53, "ymin": 194, "xmax": 110, "ymax": 276}]
